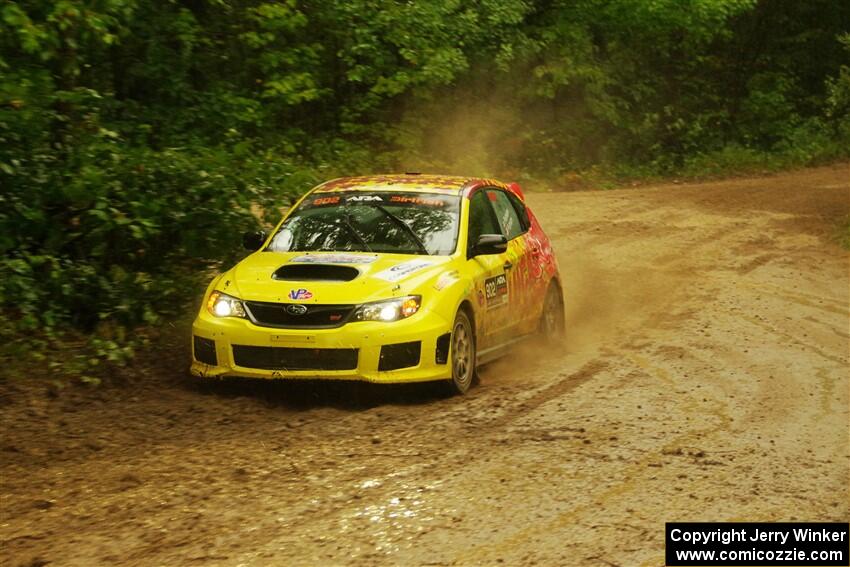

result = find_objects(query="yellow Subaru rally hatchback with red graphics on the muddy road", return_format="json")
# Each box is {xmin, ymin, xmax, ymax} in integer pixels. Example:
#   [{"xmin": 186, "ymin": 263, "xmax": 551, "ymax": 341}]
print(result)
[{"xmin": 191, "ymin": 174, "xmax": 564, "ymax": 393}]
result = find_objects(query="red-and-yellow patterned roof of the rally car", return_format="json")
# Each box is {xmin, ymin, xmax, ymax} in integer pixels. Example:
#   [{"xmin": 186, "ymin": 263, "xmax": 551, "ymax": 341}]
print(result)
[{"xmin": 313, "ymin": 173, "xmax": 505, "ymax": 195}]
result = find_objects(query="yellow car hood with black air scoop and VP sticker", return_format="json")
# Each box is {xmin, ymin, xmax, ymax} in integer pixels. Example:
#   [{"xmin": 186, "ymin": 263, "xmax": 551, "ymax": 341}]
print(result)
[{"xmin": 222, "ymin": 251, "xmax": 451, "ymax": 304}]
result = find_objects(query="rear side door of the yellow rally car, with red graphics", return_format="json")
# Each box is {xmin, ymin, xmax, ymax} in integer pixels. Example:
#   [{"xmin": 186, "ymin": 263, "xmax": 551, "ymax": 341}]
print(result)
[{"xmin": 485, "ymin": 188, "xmax": 534, "ymax": 337}]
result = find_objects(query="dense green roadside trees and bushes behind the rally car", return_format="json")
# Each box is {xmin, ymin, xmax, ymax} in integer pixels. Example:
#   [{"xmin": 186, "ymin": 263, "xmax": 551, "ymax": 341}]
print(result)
[{"xmin": 0, "ymin": 0, "xmax": 850, "ymax": 382}]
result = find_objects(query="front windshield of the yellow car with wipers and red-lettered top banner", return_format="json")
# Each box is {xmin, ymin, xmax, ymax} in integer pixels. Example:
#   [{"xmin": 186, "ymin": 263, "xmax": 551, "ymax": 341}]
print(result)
[{"xmin": 268, "ymin": 191, "xmax": 460, "ymax": 255}]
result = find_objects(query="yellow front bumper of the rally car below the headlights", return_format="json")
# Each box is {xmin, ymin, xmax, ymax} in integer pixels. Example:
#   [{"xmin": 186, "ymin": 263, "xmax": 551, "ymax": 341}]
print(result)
[{"xmin": 190, "ymin": 311, "xmax": 451, "ymax": 383}]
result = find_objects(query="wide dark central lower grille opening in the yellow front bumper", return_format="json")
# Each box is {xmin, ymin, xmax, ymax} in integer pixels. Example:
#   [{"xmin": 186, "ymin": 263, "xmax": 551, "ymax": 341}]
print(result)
[{"xmin": 233, "ymin": 345, "xmax": 357, "ymax": 370}]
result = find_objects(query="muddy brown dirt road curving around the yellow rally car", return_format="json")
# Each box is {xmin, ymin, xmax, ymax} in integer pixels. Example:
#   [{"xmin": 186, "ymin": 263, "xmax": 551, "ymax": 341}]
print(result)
[{"xmin": 0, "ymin": 165, "xmax": 850, "ymax": 566}]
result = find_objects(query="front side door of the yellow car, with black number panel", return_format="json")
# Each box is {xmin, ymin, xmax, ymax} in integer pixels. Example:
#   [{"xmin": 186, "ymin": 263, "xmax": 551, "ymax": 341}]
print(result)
[{"xmin": 467, "ymin": 190, "xmax": 511, "ymax": 354}]
